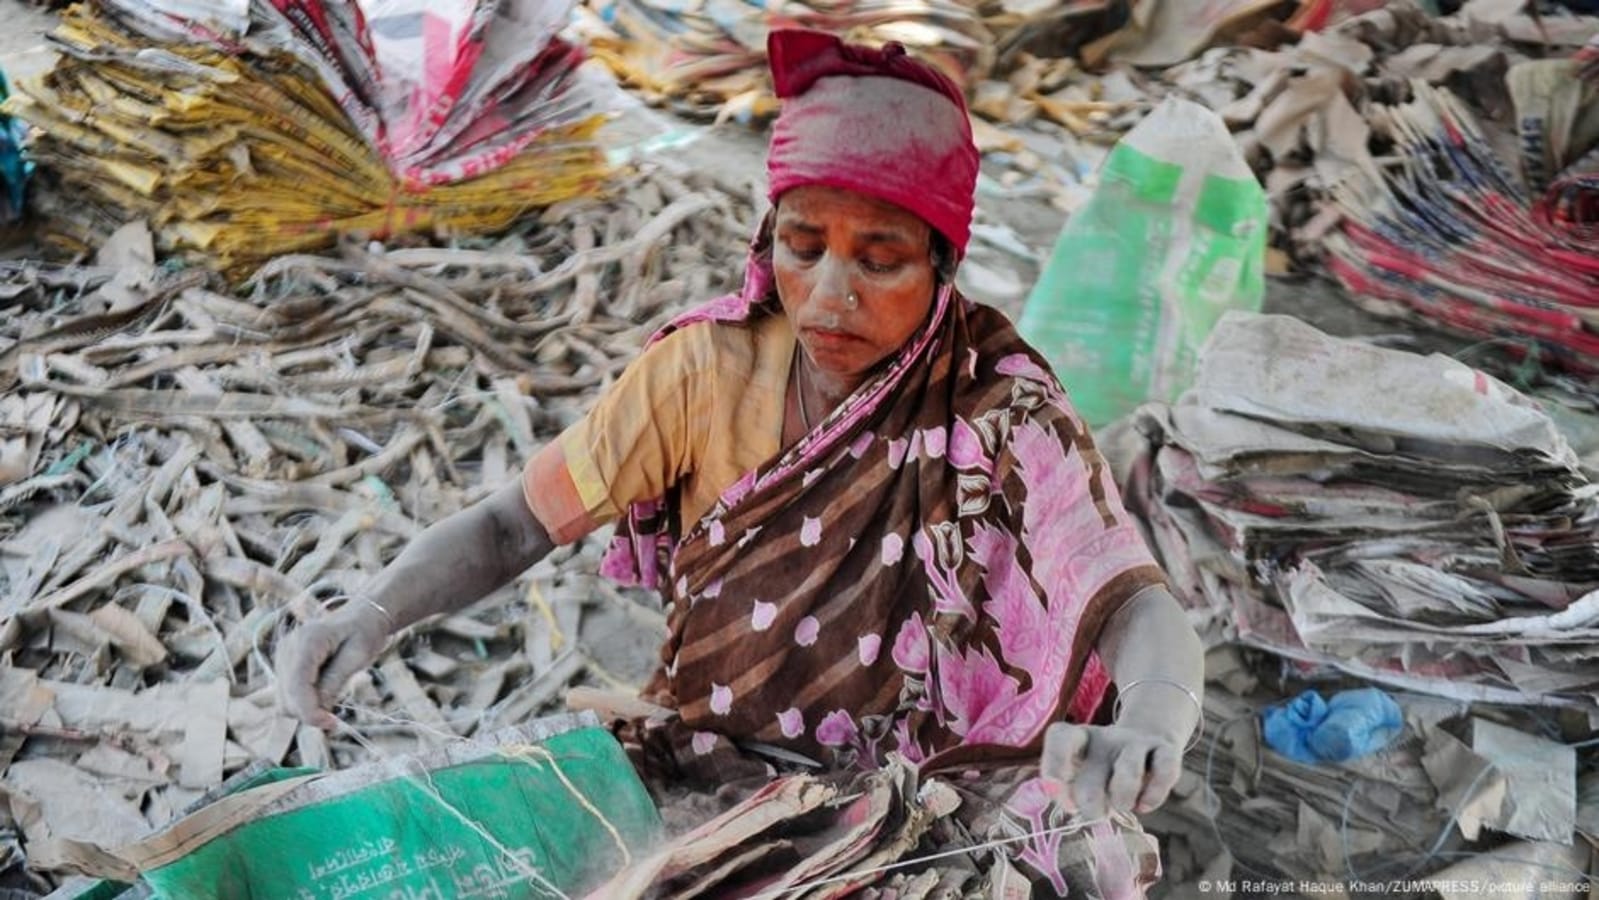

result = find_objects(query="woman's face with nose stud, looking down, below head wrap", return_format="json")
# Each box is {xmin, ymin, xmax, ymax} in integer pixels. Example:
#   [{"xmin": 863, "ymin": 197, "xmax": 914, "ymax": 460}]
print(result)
[{"xmin": 772, "ymin": 185, "xmax": 937, "ymax": 392}]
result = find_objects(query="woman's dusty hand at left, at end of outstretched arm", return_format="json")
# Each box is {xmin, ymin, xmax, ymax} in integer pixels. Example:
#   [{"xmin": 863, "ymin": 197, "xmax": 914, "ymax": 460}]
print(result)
[{"xmin": 277, "ymin": 599, "xmax": 389, "ymax": 731}]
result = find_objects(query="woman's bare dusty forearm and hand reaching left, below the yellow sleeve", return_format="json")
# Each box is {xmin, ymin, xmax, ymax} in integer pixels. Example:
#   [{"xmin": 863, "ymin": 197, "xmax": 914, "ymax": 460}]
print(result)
[{"xmin": 277, "ymin": 481, "xmax": 555, "ymax": 729}]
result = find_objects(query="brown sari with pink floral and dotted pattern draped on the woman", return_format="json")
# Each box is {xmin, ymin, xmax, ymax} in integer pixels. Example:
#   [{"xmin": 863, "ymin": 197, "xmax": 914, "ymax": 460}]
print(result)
[{"xmin": 603, "ymin": 215, "xmax": 1162, "ymax": 895}]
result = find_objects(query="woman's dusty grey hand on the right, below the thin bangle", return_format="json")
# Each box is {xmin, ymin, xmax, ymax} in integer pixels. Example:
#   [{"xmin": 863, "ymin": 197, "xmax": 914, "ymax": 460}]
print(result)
[{"xmin": 1039, "ymin": 723, "xmax": 1183, "ymax": 820}]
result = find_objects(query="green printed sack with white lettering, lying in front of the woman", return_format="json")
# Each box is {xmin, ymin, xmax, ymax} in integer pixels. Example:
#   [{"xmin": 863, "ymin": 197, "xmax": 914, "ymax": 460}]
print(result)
[{"xmin": 117, "ymin": 713, "xmax": 660, "ymax": 900}]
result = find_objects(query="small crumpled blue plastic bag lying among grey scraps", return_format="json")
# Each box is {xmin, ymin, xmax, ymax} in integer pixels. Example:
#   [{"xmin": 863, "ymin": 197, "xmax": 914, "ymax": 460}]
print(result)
[{"xmin": 1260, "ymin": 687, "xmax": 1404, "ymax": 763}]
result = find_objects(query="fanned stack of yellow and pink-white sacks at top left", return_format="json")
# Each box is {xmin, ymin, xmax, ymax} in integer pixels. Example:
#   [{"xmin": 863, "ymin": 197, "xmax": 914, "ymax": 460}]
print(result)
[{"xmin": 0, "ymin": 0, "xmax": 608, "ymax": 273}]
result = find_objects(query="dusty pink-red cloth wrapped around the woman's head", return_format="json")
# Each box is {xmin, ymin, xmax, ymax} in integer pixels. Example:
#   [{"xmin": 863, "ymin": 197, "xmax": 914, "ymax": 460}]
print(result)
[{"xmin": 766, "ymin": 29, "xmax": 979, "ymax": 256}]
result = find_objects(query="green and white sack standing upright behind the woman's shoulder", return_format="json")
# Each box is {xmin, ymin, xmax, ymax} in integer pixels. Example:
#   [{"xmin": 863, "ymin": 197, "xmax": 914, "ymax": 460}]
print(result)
[{"xmin": 1019, "ymin": 98, "xmax": 1266, "ymax": 425}]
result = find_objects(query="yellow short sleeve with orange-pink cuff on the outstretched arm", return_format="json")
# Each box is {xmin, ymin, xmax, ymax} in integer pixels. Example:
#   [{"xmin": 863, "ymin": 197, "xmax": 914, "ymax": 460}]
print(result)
[{"xmin": 523, "ymin": 325, "xmax": 715, "ymax": 536}]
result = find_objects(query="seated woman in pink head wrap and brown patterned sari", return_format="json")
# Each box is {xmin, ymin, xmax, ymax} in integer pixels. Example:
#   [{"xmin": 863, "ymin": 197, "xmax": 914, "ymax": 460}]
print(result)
[{"xmin": 280, "ymin": 30, "xmax": 1202, "ymax": 894}]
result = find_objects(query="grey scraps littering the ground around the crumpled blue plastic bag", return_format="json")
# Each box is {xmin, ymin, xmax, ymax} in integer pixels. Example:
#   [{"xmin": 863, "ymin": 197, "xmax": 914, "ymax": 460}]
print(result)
[{"xmin": 1143, "ymin": 649, "xmax": 1599, "ymax": 898}]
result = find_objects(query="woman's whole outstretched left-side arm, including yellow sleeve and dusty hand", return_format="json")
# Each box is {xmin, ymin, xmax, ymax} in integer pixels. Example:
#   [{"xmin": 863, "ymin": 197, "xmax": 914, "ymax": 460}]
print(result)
[{"xmin": 278, "ymin": 328, "xmax": 718, "ymax": 727}]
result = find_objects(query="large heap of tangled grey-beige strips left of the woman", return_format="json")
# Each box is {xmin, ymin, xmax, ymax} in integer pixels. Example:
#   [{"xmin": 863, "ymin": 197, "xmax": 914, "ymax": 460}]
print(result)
[{"xmin": 0, "ymin": 163, "xmax": 753, "ymax": 894}]
